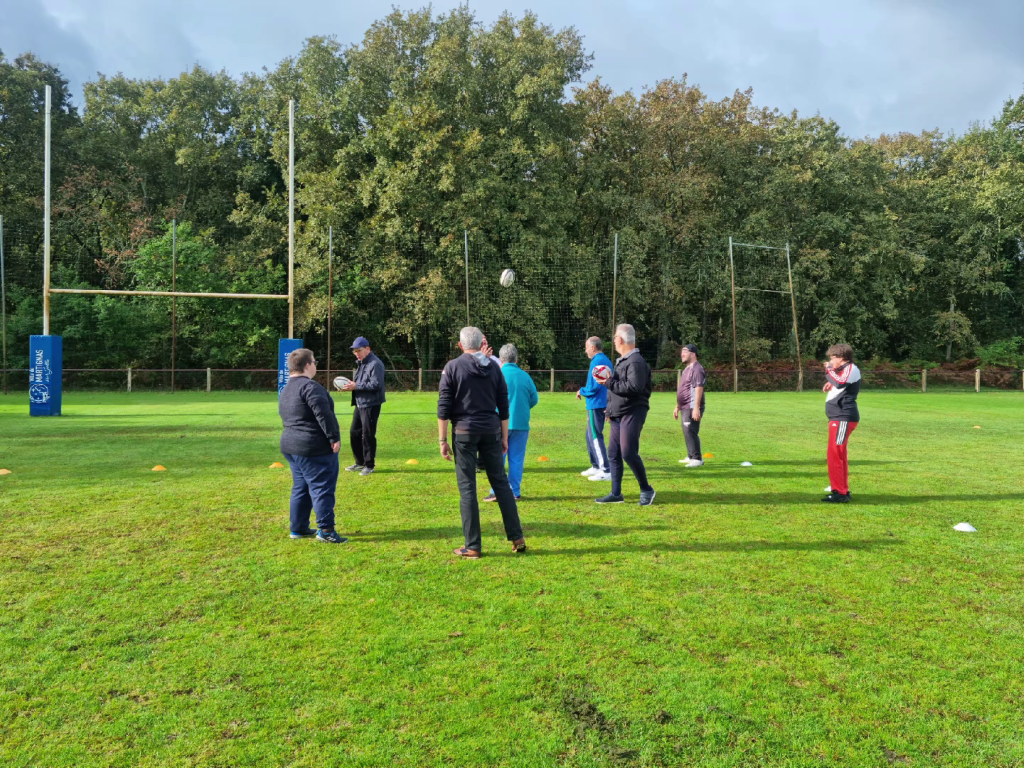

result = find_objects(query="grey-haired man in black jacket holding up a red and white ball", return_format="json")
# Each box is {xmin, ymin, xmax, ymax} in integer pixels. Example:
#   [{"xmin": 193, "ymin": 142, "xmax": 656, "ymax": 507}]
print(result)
[{"xmin": 595, "ymin": 325, "xmax": 654, "ymax": 507}]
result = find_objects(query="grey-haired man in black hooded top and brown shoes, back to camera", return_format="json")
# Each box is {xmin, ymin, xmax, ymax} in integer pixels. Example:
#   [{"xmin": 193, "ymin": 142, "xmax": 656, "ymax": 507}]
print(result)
[{"xmin": 437, "ymin": 327, "xmax": 526, "ymax": 559}]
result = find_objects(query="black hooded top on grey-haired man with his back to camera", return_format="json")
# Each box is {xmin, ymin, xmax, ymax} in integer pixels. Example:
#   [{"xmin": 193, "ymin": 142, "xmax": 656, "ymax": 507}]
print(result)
[{"xmin": 437, "ymin": 352, "xmax": 509, "ymax": 434}]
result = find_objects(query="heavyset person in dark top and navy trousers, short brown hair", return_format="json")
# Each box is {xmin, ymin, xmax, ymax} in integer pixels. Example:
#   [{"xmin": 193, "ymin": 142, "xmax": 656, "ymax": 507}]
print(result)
[{"xmin": 278, "ymin": 349, "xmax": 348, "ymax": 544}]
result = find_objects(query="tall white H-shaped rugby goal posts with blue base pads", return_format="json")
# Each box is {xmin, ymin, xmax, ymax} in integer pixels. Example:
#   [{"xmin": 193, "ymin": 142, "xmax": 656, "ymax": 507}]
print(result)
[{"xmin": 29, "ymin": 93, "xmax": 302, "ymax": 416}]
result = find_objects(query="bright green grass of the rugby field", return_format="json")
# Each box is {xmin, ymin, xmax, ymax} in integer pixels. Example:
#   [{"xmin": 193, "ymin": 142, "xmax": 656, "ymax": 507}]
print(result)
[{"xmin": 0, "ymin": 391, "xmax": 1024, "ymax": 768}]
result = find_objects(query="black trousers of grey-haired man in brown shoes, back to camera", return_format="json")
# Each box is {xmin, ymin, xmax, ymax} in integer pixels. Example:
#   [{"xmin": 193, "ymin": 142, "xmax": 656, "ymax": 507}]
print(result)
[{"xmin": 452, "ymin": 434, "xmax": 522, "ymax": 552}]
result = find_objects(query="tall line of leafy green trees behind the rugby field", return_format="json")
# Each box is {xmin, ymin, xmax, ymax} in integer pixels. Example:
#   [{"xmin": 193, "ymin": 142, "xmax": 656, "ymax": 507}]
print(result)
[{"xmin": 0, "ymin": 7, "xmax": 1024, "ymax": 369}]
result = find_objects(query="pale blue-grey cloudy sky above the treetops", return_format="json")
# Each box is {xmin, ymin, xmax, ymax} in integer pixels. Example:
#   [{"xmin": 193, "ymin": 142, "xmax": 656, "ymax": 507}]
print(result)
[{"xmin": 6, "ymin": 0, "xmax": 1024, "ymax": 137}]
